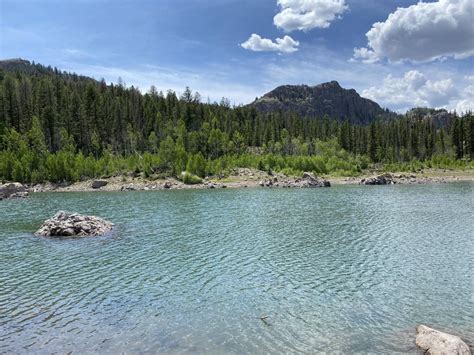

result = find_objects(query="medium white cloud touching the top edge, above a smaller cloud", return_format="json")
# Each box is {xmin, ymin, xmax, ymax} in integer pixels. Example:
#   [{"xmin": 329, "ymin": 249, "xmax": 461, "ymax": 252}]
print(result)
[{"xmin": 273, "ymin": 0, "xmax": 349, "ymax": 32}]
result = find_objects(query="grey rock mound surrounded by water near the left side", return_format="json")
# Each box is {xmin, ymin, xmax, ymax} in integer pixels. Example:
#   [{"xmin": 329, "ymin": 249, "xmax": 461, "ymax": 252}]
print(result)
[{"xmin": 35, "ymin": 211, "xmax": 113, "ymax": 237}]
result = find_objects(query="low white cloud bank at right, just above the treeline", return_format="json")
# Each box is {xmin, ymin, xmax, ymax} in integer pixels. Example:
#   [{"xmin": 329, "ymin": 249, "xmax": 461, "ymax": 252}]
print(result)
[{"xmin": 362, "ymin": 70, "xmax": 474, "ymax": 112}]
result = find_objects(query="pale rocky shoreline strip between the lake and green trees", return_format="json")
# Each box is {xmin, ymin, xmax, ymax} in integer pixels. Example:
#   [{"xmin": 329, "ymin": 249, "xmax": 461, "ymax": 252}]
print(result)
[{"xmin": 0, "ymin": 168, "xmax": 474, "ymax": 199}]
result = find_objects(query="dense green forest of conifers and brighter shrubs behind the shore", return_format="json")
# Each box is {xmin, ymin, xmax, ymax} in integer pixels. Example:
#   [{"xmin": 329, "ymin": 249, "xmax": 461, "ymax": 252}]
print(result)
[{"xmin": 0, "ymin": 60, "xmax": 474, "ymax": 182}]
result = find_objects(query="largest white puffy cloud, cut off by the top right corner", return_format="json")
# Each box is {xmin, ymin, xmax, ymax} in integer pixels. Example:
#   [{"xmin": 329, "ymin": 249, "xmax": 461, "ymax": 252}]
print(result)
[{"xmin": 353, "ymin": 0, "xmax": 474, "ymax": 63}]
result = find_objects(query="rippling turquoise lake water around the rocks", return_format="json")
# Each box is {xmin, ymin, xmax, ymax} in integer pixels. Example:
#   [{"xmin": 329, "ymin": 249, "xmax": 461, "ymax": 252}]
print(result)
[{"xmin": 0, "ymin": 183, "xmax": 474, "ymax": 354}]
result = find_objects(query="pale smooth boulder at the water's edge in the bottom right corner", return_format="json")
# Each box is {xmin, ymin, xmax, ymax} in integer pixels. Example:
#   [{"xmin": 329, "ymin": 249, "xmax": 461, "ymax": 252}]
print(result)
[{"xmin": 416, "ymin": 325, "xmax": 471, "ymax": 355}]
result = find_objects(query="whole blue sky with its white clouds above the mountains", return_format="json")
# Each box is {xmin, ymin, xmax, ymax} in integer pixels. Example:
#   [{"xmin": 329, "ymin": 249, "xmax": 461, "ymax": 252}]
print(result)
[{"xmin": 0, "ymin": 0, "xmax": 474, "ymax": 111}]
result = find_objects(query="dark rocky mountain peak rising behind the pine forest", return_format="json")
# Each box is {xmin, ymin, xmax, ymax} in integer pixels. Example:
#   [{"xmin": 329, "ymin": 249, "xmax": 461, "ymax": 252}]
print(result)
[{"xmin": 250, "ymin": 81, "xmax": 396, "ymax": 124}]
